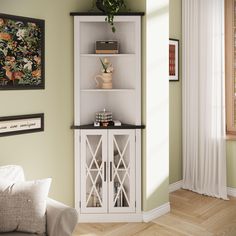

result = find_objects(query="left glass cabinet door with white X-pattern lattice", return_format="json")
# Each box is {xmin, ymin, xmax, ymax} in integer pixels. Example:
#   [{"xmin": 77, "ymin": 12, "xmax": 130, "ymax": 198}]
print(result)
[{"xmin": 81, "ymin": 130, "xmax": 107, "ymax": 213}]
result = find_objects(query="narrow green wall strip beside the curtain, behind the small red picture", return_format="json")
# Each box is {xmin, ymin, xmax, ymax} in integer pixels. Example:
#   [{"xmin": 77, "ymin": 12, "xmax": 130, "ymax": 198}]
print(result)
[{"xmin": 169, "ymin": 0, "xmax": 182, "ymax": 183}]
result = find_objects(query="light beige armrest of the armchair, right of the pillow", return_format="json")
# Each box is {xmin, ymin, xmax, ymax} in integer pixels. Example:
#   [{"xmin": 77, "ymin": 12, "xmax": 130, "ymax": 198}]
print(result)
[{"xmin": 47, "ymin": 198, "xmax": 78, "ymax": 236}]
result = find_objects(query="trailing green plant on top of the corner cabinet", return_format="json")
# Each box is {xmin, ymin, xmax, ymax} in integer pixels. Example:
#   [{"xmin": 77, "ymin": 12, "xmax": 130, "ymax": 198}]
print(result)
[{"xmin": 96, "ymin": 0, "xmax": 126, "ymax": 33}]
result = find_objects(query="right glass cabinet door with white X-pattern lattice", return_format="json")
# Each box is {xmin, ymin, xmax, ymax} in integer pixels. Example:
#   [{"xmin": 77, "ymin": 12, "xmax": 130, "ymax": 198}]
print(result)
[{"xmin": 108, "ymin": 130, "xmax": 135, "ymax": 213}]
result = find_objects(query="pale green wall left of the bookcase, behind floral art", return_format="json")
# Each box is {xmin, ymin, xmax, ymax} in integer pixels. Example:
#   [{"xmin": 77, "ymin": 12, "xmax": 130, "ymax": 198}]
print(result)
[{"xmin": 0, "ymin": 0, "xmax": 91, "ymax": 205}]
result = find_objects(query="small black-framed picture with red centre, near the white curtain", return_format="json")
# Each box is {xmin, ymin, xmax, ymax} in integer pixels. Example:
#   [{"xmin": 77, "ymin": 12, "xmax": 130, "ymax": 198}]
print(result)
[{"xmin": 169, "ymin": 39, "xmax": 179, "ymax": 81}]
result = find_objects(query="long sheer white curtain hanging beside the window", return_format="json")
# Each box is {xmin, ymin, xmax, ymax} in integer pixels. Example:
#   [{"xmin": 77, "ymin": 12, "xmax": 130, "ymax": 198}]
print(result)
[{"xmin": 182, "ymin": 0, "xmax": 227, "ymax": 199}]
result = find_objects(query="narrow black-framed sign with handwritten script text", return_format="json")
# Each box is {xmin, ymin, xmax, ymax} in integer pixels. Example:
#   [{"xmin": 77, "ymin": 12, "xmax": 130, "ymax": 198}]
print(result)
[{"xmin": 0, "ymin": 113, "xmax": 44, "ymax": 137}]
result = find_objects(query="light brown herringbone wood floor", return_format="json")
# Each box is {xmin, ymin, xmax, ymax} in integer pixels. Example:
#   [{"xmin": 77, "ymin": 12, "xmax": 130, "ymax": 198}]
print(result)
[{"xmin": 73, "ymin": 189, "xmax": 236, "ymax": 236}]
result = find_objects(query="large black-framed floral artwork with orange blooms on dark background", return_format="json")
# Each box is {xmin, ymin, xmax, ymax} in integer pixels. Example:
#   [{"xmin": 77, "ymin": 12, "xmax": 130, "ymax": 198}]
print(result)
[{"xmin": 0, "ymin": 14, "xmax": 45, "ymax": 90}]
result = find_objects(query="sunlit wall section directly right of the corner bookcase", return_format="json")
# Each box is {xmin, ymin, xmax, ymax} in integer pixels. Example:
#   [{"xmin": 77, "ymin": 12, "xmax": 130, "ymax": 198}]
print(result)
[{"xmin": 128, "ymin": 0, "xmax": 169, "ymax": 211}]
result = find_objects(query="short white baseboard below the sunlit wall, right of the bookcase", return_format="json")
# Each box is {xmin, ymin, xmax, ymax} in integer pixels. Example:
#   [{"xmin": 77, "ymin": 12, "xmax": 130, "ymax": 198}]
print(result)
[{"xmin": 143, "ymin": 202, "xmax": 170, "ymax": 222}]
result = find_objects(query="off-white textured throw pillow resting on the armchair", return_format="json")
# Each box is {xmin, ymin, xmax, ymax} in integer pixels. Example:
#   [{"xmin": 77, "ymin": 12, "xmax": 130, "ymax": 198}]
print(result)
[{"xmin": 0, "ymin": 179, "xmax": 51, "ymax": 234}]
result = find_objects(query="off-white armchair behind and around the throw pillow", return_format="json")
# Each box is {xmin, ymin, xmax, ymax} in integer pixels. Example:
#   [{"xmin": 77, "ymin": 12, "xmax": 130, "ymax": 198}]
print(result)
[{"xmin": 0, "ymin": 165, "xmax": 78, "ymax": 236}]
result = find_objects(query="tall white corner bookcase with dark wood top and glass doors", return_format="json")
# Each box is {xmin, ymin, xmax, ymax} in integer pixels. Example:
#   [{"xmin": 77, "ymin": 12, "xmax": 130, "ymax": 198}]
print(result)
[{"xmin": 71, "ymin": 13, "xmax": 143, "ymax": 222}]
